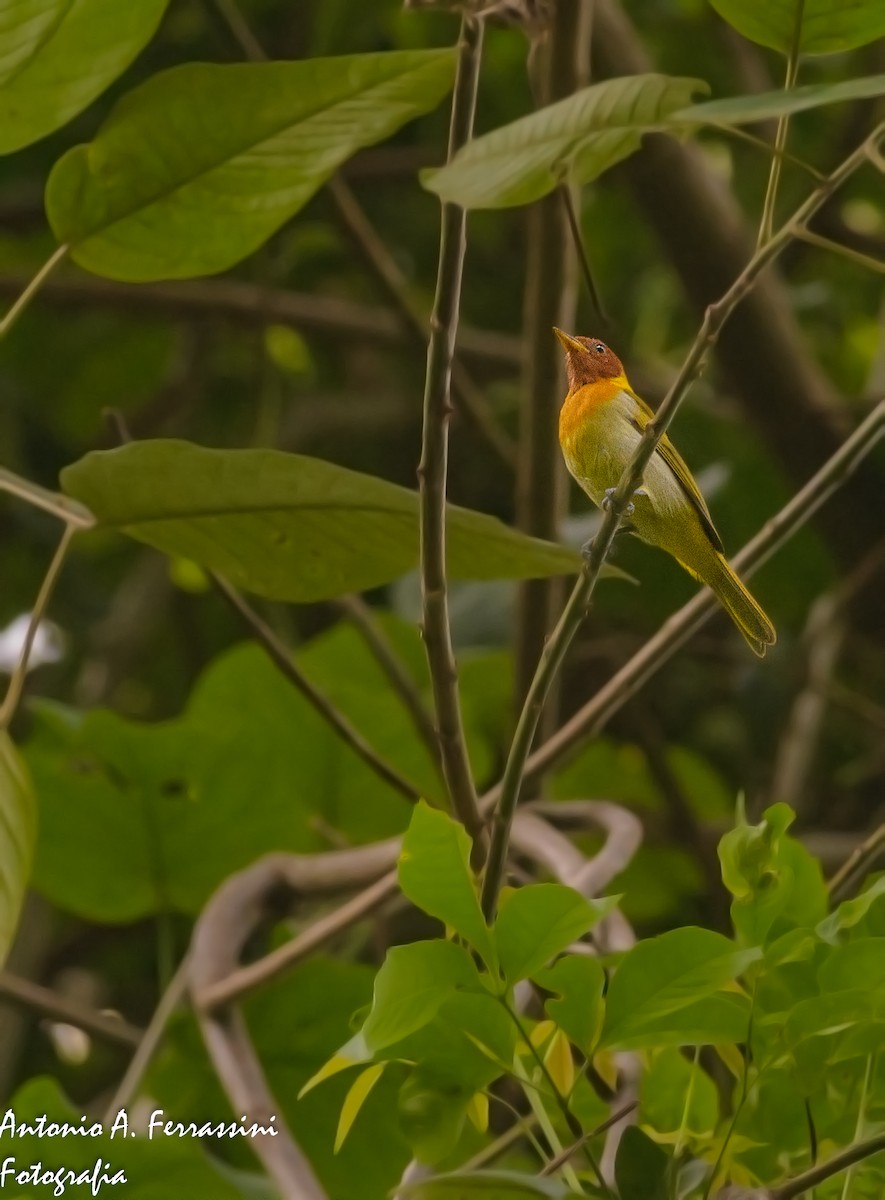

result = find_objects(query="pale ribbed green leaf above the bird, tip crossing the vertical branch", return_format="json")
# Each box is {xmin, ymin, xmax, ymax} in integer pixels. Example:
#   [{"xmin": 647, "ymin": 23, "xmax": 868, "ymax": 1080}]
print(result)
[{"xmin": 421, "ymin": 74, "xmax": 709, "ymax": 209}]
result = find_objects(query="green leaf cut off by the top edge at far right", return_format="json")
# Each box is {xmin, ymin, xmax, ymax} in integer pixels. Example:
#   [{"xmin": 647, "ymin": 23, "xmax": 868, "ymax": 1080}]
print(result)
[{"xmin": 710, "ymin": 0, "xmax": 885, "ymax": 54}]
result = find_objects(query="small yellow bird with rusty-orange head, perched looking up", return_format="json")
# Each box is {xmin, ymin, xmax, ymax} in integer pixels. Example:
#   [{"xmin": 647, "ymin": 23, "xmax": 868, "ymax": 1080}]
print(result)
[{"xmin": 553, "ymin": 326, "xmax": 777, "ymax": 658}]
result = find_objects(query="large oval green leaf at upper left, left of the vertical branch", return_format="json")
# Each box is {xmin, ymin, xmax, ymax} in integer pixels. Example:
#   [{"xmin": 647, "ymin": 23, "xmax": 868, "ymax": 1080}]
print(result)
[{"xmin": 46, "ymin": 50, "xmax": 454, "ymax": 281}]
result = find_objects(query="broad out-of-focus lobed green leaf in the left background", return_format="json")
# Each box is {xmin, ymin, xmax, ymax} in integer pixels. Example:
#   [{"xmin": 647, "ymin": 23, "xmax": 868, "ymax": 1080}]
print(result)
[{"xmin": 26, "ymin": 626, "xmax": 441, "ymax": 923}]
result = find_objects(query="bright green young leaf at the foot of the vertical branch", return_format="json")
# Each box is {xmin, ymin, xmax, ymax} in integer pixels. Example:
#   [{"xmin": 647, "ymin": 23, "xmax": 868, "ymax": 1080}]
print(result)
[{"xmin": 398, "ymin": 800, "xmax": 496, "ymax": 970}]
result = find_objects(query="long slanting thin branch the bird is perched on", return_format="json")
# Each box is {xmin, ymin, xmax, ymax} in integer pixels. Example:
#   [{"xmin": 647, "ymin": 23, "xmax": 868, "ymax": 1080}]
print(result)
[{"xmin": 482, "ymin": 122, "xmax": 885, "ymax": 920}]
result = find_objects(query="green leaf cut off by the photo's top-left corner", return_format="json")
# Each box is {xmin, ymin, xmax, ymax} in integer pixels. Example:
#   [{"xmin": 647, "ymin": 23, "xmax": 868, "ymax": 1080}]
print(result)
[{"xmin": 0, "ymin": 0, "xmax": 169, "ymax": 154}]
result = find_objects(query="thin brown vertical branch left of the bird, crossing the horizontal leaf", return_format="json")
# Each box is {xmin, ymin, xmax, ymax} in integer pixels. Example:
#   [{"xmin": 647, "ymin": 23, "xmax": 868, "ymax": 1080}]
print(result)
[{"xmin": 417, "ymin": 16, "xmax": 483, "ymax": 852}]
